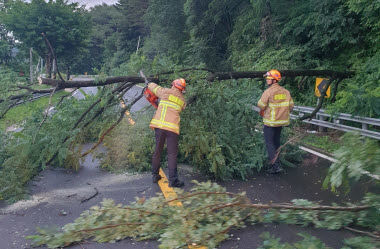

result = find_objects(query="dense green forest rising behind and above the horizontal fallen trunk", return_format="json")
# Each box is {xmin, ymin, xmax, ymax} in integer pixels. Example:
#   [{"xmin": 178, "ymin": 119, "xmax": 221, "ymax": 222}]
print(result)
[{"xmin": 0, "ymin": 0, "xmax": 380, "ymax": 117}]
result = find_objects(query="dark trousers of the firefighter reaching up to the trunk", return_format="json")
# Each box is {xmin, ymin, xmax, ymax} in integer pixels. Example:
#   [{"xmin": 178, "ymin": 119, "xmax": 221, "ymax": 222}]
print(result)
[{"xmin": 152, "ymin": 128, "xmax": 178, "ymax": 182}]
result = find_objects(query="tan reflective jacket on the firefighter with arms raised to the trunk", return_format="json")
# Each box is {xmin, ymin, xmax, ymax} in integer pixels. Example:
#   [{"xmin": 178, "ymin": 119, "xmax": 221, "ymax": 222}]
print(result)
[{"xmin": 148, "ymin": 83, "xmax": 186, "ymax": 134}]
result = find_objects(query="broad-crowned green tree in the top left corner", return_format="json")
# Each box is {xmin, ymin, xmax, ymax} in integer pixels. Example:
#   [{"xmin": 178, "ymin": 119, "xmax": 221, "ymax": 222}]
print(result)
[{"xmin": 1, "ymin": 0, "xmax": 90, "ymax": 74}]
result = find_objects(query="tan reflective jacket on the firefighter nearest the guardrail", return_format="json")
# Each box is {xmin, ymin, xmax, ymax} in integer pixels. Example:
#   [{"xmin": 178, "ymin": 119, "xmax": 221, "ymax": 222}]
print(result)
[{"xmin": 257, "ymin": 83, "xmax": 294, "ymax": 127}]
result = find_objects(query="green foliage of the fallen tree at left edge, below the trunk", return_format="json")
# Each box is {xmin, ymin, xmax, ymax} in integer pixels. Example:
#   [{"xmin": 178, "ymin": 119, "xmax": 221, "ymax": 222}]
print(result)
[{"xmin": 0, "ymin": 91, "xmax": 120, "ymax": 202}]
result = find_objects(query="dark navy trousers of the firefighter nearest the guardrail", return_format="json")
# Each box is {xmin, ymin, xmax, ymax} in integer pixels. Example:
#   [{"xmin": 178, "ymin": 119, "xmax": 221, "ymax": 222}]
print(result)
[{"xmin": 264, "ymin": 125, "xmax": 282, "ymax": 165}]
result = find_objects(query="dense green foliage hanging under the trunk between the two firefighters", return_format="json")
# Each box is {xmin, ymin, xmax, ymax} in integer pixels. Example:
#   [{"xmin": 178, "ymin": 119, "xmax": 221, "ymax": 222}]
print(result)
[{"xmin": 180, "ymin": 77, "xmax": 290, "ymax": 179}]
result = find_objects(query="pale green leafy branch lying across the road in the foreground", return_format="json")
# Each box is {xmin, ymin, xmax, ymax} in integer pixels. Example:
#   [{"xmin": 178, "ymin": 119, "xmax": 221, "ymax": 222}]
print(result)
[{"xmin": 29, "ymin": 182, "xmax": 379, "ymax": 249}]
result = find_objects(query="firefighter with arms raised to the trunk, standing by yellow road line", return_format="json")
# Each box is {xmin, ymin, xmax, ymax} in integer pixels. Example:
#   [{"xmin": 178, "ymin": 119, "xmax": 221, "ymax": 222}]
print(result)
[{"xmin": 148, "ymin": 78, "xmax": 186, "ymax": 187}]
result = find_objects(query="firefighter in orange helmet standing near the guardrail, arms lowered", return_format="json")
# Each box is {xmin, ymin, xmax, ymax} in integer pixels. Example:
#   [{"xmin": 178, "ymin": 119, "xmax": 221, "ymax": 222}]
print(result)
[{"xmin": 257, "ymin": 69, "xmax": 294, "ymax": 174}]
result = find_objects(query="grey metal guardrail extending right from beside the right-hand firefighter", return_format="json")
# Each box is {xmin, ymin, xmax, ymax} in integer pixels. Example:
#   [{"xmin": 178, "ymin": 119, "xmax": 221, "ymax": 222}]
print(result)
[{"xmin": 290, "ymin": 106, "xmax": 380, "ymax": 140}]
